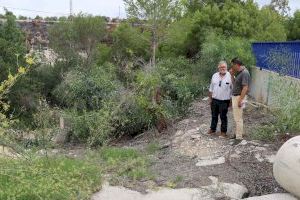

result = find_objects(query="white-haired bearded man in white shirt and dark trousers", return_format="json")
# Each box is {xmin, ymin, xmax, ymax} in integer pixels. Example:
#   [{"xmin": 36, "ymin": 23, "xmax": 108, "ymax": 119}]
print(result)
[{"xmin": 208, "ymin": 61, "xmax": 232, "ymax": 137}]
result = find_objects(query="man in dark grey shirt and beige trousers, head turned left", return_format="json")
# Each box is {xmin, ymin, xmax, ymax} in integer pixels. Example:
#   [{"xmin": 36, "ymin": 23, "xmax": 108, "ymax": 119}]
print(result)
[{"xmin": 230, "ymin": 58, "xmax": 250, "ymax": 142}]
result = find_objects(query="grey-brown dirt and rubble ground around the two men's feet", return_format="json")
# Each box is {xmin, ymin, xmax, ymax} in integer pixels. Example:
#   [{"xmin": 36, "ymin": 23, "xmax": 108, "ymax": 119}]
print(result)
[{"xmin": 117, "ymin": 100, "xmax": 284, "ymax": 196}]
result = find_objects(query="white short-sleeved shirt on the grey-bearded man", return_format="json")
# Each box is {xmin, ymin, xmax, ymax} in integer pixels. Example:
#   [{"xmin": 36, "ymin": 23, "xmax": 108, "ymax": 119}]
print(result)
[{"xmin": 209, "ymin": 72, "xmax": 232, "ymax": 100}]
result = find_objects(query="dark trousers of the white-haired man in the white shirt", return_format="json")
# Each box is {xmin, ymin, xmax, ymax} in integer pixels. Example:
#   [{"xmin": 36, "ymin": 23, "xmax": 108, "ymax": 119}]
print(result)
[{"xmin": 210, "ymin": 99, "xmax": 230, "ymax": 133}]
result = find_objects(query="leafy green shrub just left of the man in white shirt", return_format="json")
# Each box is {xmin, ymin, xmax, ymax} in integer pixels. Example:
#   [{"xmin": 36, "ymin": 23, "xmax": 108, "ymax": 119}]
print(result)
[{"xmin": 157, "ymin": 57, "xmax": 208, "ymax": 114}]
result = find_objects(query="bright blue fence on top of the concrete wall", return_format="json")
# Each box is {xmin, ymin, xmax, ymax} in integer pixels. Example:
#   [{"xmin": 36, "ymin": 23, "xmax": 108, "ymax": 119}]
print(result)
[{"xmin": 252, "ymin": 41, "xmax": 300, "ymax": 78}]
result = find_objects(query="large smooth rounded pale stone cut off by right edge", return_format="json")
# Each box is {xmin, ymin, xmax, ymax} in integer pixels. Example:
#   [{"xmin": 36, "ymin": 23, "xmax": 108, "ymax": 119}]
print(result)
[{"xmin": 273, "ymin": 136, "xmax": 300, "ymax": 198}]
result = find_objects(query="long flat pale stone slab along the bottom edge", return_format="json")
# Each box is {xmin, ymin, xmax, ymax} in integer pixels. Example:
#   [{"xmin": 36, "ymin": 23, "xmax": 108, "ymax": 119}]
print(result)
[{"xmin": 91, "ymin": 177, "xmax": 248, "ymax": 200}]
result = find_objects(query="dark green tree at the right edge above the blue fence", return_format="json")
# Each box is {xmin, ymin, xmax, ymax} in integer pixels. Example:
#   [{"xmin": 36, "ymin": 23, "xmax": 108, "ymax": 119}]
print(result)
[{"xmin": 287, "ymin": 10, "xmax": 300, "ymax": 40}]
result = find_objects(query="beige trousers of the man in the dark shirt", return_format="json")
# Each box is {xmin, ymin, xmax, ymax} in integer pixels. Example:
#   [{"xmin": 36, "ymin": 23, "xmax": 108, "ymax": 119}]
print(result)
[{"xmin": 232, "ymin": 96, "xmax": 247, "ymax": 139}]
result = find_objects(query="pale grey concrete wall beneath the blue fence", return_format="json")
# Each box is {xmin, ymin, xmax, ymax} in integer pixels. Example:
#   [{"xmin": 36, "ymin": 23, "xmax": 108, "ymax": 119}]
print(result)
[{"xmin": 249, "ymin": 67, "xmax": 300, "ymax": 106}]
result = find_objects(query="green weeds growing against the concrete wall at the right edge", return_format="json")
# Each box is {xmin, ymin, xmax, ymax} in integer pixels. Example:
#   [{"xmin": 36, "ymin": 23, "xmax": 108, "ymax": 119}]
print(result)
[{"xmin": 251, "ymin": 75, "xmax": 300, "ymax": 141}]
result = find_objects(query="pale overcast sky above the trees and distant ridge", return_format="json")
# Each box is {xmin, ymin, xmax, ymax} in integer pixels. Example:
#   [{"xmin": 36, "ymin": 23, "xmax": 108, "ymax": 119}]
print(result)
[{"xmin": 0, "ymin": 0, "xmax": 300, "ymax": 18}]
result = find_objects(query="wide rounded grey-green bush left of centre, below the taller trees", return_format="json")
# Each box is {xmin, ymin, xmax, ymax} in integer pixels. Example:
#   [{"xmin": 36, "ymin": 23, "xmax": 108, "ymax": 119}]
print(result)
[{"xmin": 53, "ymin": 63, "xmax": 119, "ymax": 110}]
